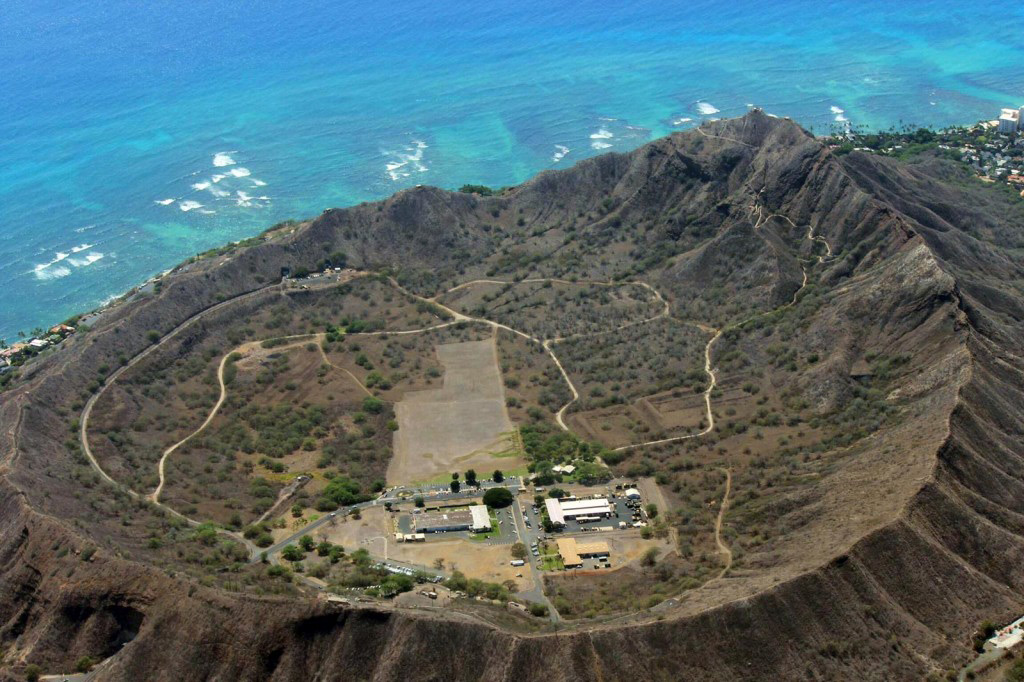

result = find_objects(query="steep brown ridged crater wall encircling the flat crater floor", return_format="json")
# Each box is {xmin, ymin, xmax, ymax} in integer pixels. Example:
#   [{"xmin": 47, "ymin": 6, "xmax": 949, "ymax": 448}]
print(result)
[{"xmin": 0, "ymin": 113, "xmax": 1024, "ymax": 681}]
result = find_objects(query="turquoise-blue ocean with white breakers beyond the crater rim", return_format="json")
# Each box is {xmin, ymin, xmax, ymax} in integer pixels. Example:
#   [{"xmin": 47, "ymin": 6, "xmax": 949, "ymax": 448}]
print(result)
[{"xmin": 0, "ymin": 0, "xmax": 1024, "ymax": 341}]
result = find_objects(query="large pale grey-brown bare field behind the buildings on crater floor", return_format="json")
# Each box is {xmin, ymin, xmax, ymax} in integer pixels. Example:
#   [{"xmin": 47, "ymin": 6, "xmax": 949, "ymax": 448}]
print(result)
[{"xmin": 387, "ymin": 338, "xmax": 522, "ymax": 484}]
